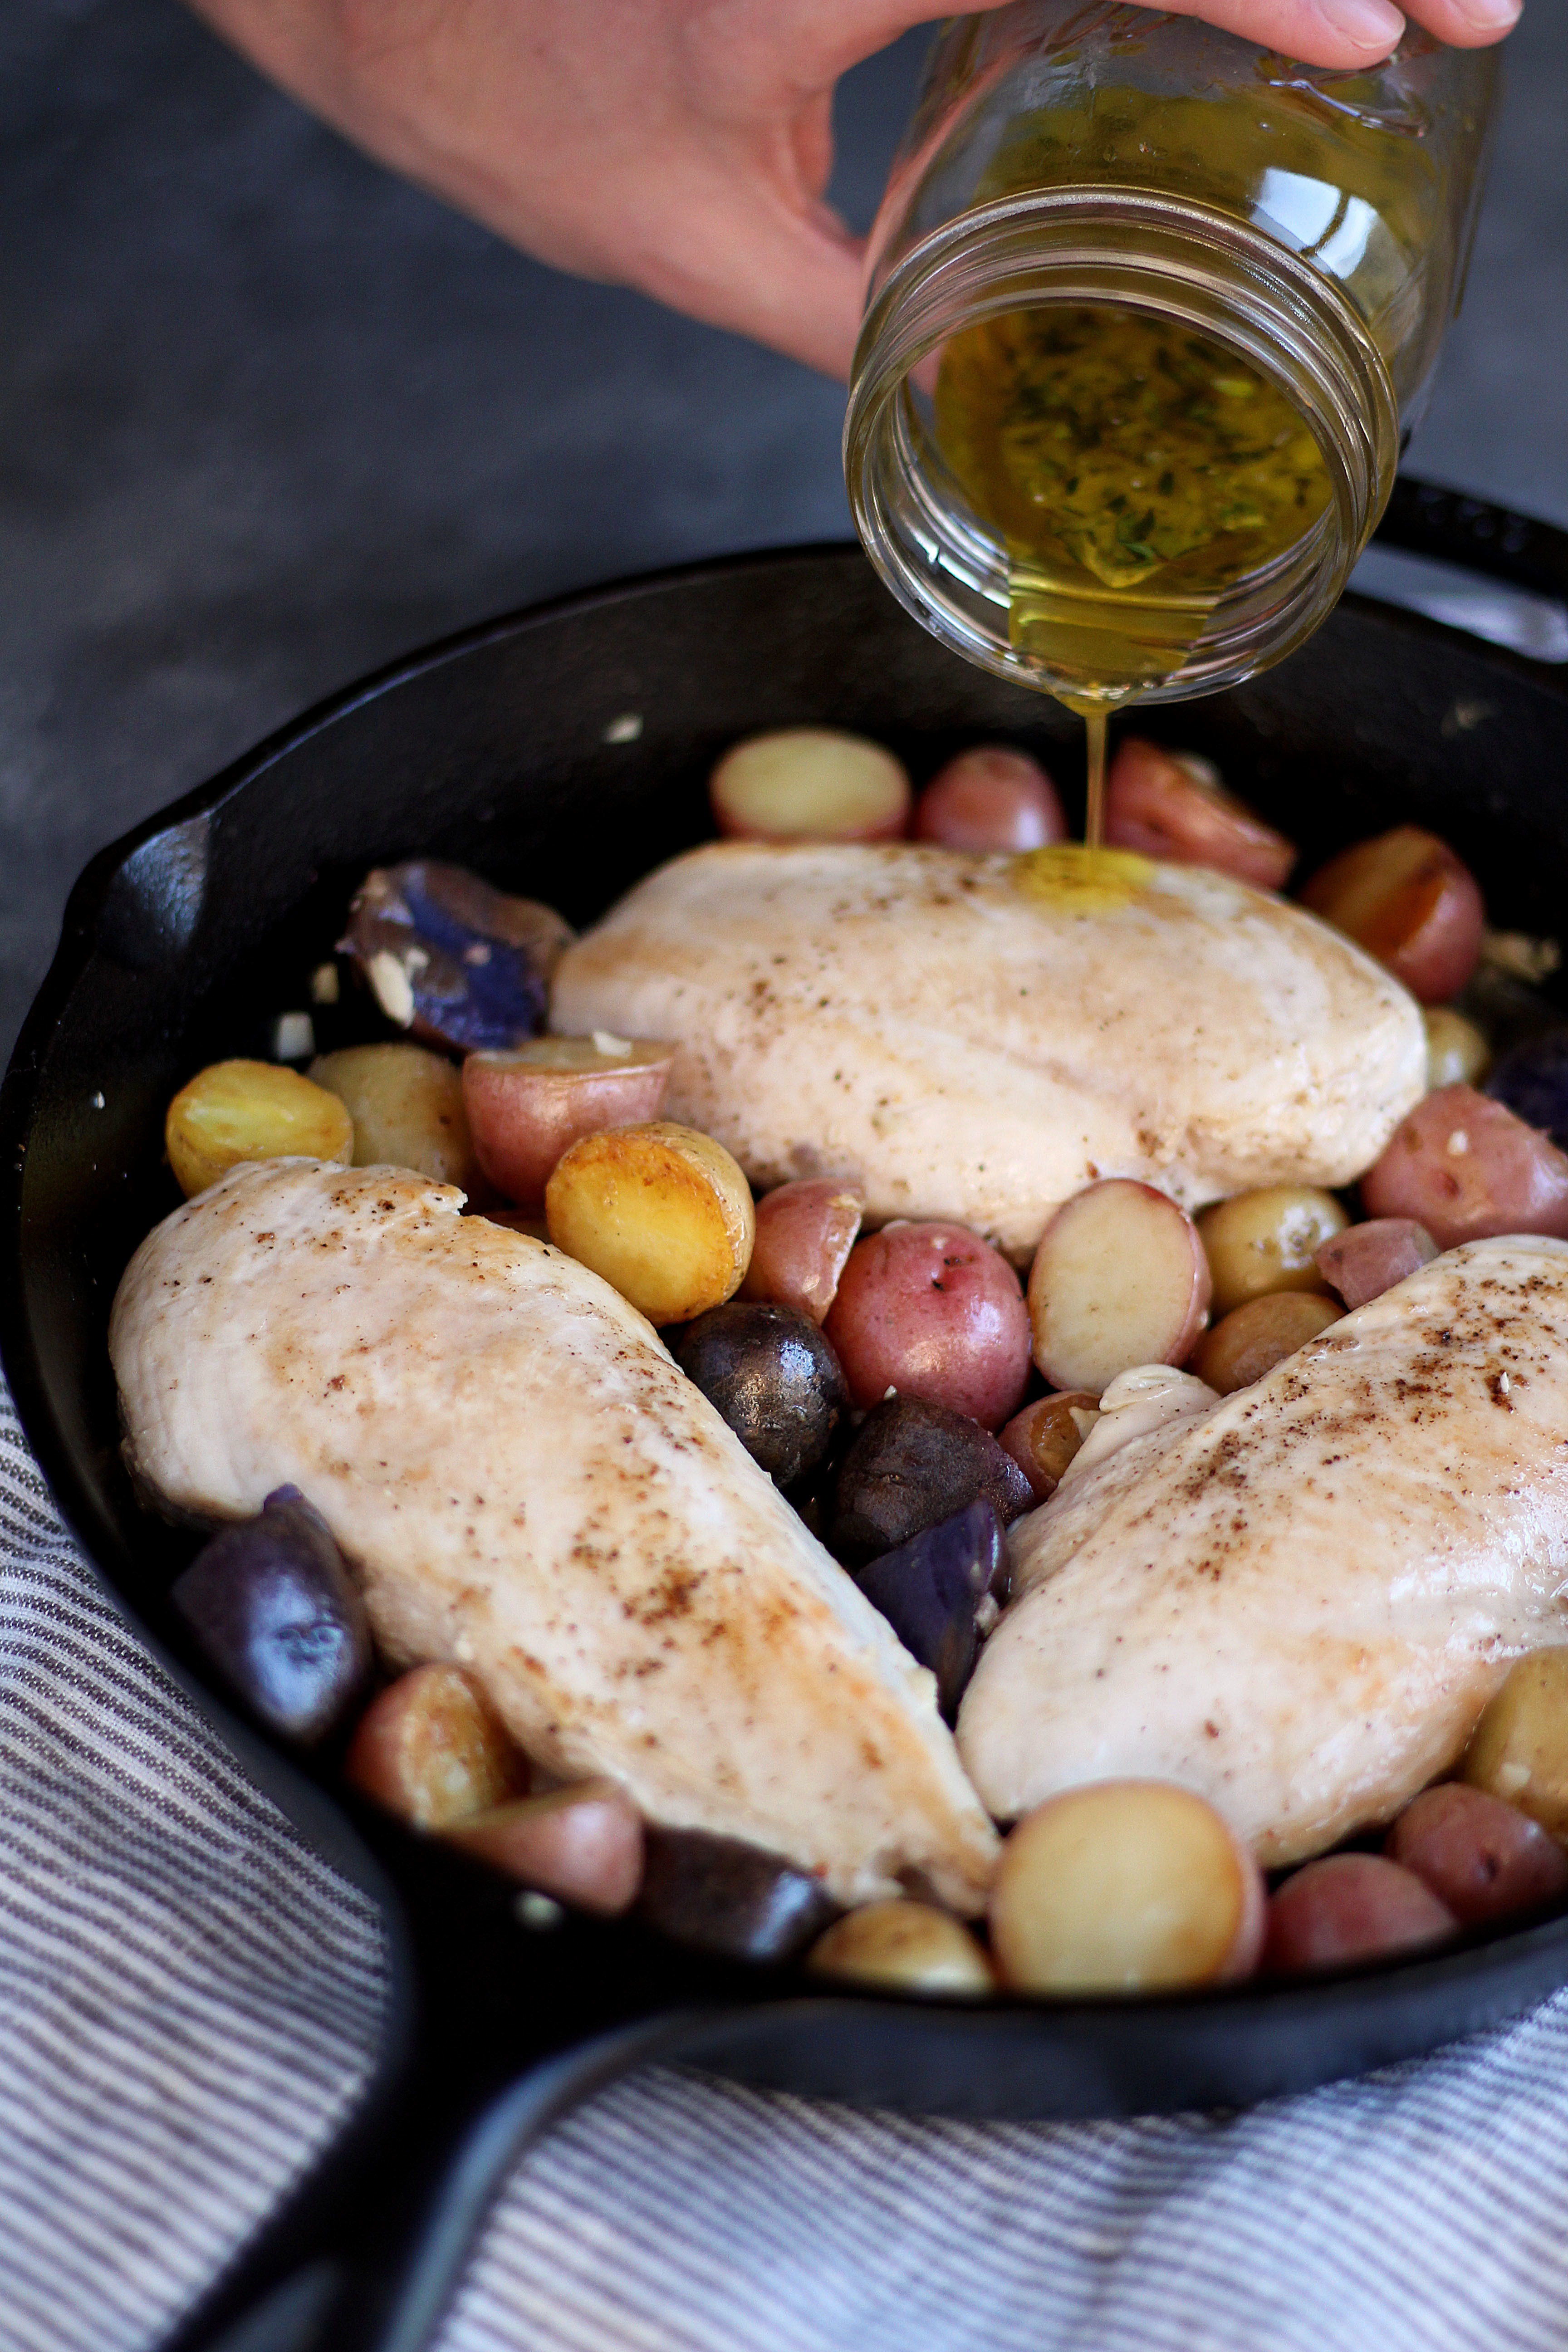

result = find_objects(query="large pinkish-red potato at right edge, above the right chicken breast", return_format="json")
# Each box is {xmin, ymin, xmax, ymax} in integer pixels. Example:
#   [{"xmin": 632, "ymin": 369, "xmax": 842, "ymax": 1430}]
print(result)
[{"xmin": 1361, "ymin": 1087, "xmax": 1568, "ymax": 1249}]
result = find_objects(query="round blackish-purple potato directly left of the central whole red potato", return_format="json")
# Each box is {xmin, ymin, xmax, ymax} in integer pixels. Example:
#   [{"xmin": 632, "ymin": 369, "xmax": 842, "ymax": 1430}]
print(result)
[{"xmin": 670, "ymin": 1298, "xmax": 848, "ymax": 1486}]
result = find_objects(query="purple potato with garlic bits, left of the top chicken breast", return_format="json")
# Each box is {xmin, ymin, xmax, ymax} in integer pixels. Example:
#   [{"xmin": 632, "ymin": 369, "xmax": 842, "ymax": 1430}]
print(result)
[{"xmin": 338, "ymin": 858, "xmax": 576, "ymax": 1054}]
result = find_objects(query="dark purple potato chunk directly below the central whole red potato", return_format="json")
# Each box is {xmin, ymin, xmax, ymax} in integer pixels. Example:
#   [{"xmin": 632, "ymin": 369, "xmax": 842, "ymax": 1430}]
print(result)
[{"xmin": 828, "ymin": 1397, "xmax": 1034, "ymax": 1569}]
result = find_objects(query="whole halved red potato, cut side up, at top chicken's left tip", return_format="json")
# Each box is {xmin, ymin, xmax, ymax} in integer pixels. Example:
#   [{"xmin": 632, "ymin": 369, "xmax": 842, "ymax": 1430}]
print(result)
[{"xmin": 463, "ymin": 1030, "xmax": 675, "ymax": 1209}]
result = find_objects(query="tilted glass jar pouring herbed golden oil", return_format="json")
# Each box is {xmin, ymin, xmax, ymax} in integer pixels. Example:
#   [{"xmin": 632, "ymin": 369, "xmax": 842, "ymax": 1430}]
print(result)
[{"xmin": 844, "ymin": 0, "xmax": 1498, "ymax": 713}]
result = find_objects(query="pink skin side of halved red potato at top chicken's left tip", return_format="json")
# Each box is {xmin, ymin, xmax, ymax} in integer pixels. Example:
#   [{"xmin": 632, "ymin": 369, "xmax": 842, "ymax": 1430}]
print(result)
[{"xmin": 463, "ymin": 1049, "xmax": 675, "ymax": 1211}]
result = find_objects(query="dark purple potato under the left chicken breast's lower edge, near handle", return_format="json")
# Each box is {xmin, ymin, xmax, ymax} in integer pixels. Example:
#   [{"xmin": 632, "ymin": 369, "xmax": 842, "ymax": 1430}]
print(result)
[{"xmin": 637, "ymin": 1828, "xmax": 839, "ymax": 1961}]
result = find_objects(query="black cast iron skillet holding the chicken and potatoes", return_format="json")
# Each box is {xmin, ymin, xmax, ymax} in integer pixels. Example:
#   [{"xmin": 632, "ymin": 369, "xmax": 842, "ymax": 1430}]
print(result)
[{"xmin": 0, "ymin": 485, "xmax": 1568, "ymax": 2352}]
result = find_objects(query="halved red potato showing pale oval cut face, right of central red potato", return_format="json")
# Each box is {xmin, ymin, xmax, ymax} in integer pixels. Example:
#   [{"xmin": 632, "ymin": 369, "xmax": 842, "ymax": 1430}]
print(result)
[{"xmin": 1029, "ymin": 1176, "xmax": 1213, "ymax": 1397}]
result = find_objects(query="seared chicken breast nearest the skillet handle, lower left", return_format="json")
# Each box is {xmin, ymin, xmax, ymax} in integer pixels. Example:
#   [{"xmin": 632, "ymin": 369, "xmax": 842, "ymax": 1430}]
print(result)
[{"xmin": 111, "ymin": 1160, "xmax": 997, "ymax": 1912}]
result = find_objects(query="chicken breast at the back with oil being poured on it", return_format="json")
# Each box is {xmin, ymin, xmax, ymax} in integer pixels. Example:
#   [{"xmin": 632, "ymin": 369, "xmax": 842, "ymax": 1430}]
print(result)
[{"xmin": 550, "ymin": 842, "xmax": 1427, "ymax": 1256}]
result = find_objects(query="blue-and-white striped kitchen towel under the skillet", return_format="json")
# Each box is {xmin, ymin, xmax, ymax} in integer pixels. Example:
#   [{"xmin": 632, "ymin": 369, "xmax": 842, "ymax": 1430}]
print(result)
[{"xmin": 0, "ymin": 1392, "xmax": 1568, "ymax": 2352}]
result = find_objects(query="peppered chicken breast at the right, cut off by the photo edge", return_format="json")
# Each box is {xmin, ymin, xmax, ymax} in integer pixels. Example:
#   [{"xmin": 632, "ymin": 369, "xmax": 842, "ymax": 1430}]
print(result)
[{"xmin": 959, "ymin": 1240, "xmax": 1568, "ymax": 1863}]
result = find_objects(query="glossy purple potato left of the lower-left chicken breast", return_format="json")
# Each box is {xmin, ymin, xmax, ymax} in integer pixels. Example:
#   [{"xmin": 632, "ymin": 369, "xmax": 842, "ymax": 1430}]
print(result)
[{"xmin": 172, "ymin": 1486, "xmax": 372, "ymax": 1748}]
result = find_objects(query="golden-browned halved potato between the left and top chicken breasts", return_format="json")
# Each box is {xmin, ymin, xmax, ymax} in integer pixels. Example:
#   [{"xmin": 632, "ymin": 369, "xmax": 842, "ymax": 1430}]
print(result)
[{"xmin": 545, "ymin": 1120, "xmax": 755, "ymax": 1324}]
